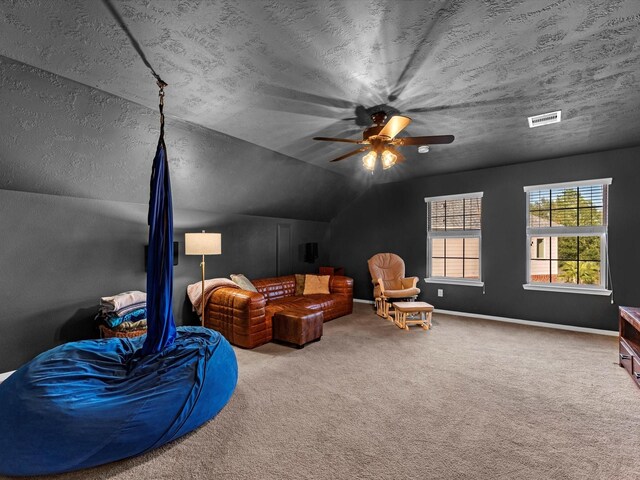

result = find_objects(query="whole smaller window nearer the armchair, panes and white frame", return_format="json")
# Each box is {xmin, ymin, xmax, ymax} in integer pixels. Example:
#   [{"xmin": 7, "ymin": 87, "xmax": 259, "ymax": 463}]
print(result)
[{"xmin": 425, "ymin": 192, "xmax": 483, "ymax": 286}]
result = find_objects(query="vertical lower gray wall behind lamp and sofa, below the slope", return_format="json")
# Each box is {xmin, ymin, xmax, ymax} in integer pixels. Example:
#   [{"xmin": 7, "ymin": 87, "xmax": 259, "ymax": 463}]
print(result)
[{"xmin": 0, "ymin": 190, "xmax": 329, "ymax": 372}]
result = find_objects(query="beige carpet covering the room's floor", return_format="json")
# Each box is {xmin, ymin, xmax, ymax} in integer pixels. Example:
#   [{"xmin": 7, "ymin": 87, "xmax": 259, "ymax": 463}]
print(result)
[{"xmin": 12, "ymin": 304, "xmax": 640, "ymax": 480}]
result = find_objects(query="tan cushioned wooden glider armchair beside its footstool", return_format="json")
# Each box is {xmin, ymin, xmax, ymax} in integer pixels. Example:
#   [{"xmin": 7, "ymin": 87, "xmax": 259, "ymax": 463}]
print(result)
[{"xmin": 367, "ymin": 253, "xmax": 420, "ymax": 318}]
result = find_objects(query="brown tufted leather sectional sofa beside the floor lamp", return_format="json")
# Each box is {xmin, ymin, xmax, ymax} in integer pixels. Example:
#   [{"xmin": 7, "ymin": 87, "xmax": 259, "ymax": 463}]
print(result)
[{"xmin": 204, "ymin": 275, "xmax": 353, "ymax": 348}]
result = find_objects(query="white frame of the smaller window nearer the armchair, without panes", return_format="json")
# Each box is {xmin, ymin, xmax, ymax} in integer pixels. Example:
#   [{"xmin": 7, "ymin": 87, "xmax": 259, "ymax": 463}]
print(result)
[{"xmin": 424, "ymin": 192, "xmax": 484, "ymax": 287}]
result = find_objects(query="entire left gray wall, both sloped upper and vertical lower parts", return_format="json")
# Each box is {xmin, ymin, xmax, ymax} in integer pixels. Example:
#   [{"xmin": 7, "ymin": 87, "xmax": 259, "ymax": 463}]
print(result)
[{"xmin": 0, "ymin": 56, "xmax": 344, "ymax": 372}]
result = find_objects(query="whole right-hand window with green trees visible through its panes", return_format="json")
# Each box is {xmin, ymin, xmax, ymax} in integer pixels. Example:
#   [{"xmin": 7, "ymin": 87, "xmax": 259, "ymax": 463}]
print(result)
[{"xmin": 524, "ymin": 178, "xmax": 611, "ymax": 295}]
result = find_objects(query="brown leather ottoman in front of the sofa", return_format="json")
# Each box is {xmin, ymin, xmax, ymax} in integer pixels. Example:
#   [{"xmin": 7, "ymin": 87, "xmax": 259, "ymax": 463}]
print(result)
[{"xmin": 272, "ymin": 307, "xmax": 324, "ymax": 348}]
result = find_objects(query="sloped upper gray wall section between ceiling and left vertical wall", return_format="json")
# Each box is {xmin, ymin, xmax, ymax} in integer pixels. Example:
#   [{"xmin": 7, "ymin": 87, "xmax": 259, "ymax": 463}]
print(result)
[{"xmin": 0, "ymin": 56, "xmax": 361, "ymax": 221}]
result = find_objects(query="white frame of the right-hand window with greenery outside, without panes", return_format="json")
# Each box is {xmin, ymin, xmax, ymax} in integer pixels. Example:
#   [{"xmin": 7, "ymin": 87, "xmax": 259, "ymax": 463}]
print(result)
[{"xmin": 522, "ymin": 178, "xmax": 613, "ymax": 296}]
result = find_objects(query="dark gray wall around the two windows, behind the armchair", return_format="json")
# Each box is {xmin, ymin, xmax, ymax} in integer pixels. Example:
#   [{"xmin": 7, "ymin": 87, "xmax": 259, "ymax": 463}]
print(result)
[{"xmin": 331, "ymin": 148, "xmax": 640, "ymax": 330}]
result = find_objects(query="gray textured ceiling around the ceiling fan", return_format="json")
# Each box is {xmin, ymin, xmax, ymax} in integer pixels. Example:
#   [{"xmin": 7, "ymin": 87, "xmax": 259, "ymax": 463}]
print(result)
[{"xmin": 0, "ymin": 0, "xmax": 640, "ymax": 182}]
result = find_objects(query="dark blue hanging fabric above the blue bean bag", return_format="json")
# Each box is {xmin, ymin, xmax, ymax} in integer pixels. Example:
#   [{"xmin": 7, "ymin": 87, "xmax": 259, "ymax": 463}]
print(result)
[{"xmin": 139, "ymin": 135, "xmax": 176, "ymax": 355}]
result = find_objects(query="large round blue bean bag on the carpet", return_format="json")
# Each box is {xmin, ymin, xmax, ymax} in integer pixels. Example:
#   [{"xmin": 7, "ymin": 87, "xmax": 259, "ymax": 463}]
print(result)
[{"xmin": 0, "ymin": 327, "xmax": 238, "ymax": 475}]
